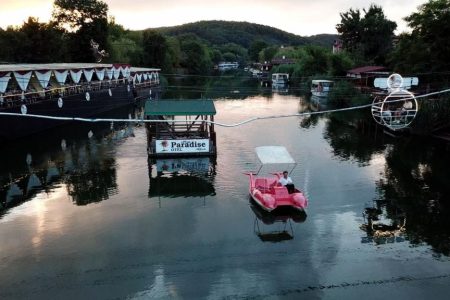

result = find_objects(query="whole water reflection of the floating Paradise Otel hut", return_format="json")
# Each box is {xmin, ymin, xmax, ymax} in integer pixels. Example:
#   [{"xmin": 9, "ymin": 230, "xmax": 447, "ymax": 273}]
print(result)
[{"xmin": 148, "ymin": 157, "xmax": 216, "ymax": 198}]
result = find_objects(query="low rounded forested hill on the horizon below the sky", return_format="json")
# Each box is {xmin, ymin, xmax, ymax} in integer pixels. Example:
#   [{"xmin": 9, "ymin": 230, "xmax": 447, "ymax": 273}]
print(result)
[{"xmin": 149, "ymin": 21, "xmax": 330, "ymax": 49}]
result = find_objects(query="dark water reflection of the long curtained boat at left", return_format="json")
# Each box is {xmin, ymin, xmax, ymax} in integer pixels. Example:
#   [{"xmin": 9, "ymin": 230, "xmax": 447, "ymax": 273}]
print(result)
[{"xmin": 0, "ymin": 107, "xmax": 142, "ymax": 216}]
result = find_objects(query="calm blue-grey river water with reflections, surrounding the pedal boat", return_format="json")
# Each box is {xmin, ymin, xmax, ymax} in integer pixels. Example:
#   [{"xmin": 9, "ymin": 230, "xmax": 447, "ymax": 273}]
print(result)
[{"xmin": 0, "ymin": 83, "xmax": 450, "ymax": 299}]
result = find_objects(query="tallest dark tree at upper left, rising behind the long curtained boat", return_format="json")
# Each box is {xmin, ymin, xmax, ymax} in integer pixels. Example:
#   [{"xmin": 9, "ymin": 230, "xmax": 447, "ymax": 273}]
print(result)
[{"xmin": 52, "ymin": 0, "xmax": 109, "ymax": 62}]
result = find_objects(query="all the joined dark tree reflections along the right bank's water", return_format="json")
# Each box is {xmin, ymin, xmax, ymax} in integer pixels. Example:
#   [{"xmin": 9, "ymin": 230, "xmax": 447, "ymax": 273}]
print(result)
[{"xmin": 318, "ymin": 101, "xmax": 450, "ymax": 256}]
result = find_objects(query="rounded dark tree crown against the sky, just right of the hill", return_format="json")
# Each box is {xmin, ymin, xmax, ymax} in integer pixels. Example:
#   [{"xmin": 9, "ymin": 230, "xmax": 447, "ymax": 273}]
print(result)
[{"xmin": 336, "ymin": 4, "xmax": 397, "ymax": 64}]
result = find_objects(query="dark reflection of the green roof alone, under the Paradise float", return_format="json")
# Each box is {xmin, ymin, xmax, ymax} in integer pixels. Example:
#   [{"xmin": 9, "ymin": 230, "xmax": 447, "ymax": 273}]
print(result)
[{"xmin": 148, "ymin": 175, "xmax": 215, "ymax": 197}]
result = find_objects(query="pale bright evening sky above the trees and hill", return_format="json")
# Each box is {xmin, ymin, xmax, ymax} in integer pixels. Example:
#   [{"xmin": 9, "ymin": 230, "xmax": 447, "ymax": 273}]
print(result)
[{"xmin": 0, "ymin": 0, "xmax": 427, "ymax": 36}]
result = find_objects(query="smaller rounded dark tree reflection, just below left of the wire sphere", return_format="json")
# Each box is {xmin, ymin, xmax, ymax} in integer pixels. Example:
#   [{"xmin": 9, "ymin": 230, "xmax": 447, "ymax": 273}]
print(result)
[{"xmin": 324, "ymin": 111, "xmax": 384, "ymax": 164}]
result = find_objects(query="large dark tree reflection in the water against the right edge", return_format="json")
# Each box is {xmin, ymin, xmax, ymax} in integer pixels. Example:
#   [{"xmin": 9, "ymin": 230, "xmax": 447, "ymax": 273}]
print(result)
[{"xmin": 378, "ymin": 140, "xmax": 450, "ymax": 255}]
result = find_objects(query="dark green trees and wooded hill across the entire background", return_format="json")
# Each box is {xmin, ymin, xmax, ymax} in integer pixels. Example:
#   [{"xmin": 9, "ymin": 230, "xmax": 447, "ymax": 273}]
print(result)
[{"xmin": 0, "ymin": 0, "xmax": 450, "ymax": 134}]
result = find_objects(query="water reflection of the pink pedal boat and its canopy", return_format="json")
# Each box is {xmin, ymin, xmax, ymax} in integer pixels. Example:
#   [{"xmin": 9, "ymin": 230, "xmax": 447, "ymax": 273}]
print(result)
[{"xmin": 249, "ymin": 197, "xmax": 306, "ymax": 243}]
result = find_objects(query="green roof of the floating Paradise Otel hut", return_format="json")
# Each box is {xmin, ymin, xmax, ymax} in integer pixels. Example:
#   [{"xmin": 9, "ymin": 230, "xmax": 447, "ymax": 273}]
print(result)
[{"xmin": 145, "ymin": 99, "xmax": 216, "ymax": 116}]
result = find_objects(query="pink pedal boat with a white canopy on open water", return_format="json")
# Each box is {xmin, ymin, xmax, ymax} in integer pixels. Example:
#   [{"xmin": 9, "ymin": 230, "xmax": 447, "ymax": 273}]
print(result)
[{"xmin": 246, "ymin": 146, "xmax": 308, "ymax": 212}]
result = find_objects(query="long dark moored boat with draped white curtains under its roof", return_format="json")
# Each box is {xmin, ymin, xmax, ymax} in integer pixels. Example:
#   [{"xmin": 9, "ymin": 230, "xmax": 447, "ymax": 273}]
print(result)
[{"xmin": 0, "ymin": 63, "xmax": 160, "ymax": 140}]
